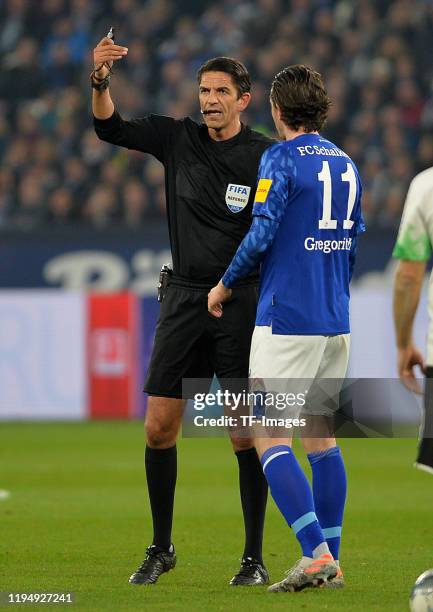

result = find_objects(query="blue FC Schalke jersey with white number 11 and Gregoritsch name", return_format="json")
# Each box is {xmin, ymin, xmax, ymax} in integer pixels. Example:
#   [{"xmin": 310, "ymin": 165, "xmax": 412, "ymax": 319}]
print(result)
[{"xmin": 253, "ymin": 134, "xmax": 365, "ymax": 335}]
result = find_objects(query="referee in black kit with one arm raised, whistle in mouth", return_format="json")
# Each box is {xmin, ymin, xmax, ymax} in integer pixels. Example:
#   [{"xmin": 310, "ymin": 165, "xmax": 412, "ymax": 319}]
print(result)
[{"xmin": 91, "ymin": 36, "xmax": 274, "ymax": 585}]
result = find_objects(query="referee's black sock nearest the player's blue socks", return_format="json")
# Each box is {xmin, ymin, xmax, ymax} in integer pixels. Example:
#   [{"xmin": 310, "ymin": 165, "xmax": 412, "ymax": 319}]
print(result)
[{"xmin": 235, "ymin": 448, "xmax": 268, "ymax": 563}]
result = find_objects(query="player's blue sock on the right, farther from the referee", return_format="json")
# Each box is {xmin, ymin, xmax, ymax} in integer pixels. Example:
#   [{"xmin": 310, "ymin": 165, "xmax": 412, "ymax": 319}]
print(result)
[{"xmin": 308, "ymin": 446, "xmax": 347, "ymax": 559}]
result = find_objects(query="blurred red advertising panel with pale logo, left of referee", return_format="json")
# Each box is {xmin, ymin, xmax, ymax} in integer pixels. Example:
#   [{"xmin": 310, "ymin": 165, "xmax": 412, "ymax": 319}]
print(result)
[{"xmin": 87, "ymin": 293, "xmax": 139, "ymax": 419}]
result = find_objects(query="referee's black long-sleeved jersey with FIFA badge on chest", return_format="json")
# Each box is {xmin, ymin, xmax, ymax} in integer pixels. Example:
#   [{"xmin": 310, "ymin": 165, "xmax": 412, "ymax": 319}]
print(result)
[{"xmin": 94, "ymin": 111, "xmax": 275, "ymax": 285}]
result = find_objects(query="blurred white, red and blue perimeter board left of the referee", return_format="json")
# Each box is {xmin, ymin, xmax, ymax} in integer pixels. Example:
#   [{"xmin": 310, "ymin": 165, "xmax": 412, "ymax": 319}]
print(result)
[{"xmin": 0, "ymin": 290, "xmax": 158, "ymax": 420}]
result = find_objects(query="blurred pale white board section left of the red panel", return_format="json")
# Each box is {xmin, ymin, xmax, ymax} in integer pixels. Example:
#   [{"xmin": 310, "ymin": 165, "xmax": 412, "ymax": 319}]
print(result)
[{"xmin": 0, "ymin": 290, "xmax": 87, "ymax": 420}]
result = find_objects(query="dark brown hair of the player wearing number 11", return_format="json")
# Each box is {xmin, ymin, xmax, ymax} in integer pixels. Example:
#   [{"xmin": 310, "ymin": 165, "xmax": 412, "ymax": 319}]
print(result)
[{"xmin": 270, "ymin": 64, "xmax": 331, "ymax": 132}]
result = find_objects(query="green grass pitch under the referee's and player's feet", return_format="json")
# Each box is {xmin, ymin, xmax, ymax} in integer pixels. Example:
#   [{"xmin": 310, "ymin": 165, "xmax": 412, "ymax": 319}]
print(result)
[{"xmin": 0, "ymin": 422, "xmax": 433, "ymax": 612}]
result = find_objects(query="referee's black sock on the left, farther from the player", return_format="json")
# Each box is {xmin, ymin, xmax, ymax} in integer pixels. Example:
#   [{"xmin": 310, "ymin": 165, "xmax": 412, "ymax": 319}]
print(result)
[{"xmin": 145, "ymin": 445, "xmax": 177, "ymax": 551}]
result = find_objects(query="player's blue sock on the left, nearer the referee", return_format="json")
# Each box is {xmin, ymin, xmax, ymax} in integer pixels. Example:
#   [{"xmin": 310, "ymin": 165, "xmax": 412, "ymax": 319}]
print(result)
[{"xmin": 261, "ymin": 445, "xmax": 328, "ymax": 557}]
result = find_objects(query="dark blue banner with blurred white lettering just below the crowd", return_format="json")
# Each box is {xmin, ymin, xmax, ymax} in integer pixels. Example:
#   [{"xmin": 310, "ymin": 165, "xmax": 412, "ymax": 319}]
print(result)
[{"xmin": 0, "ymin": 222, "xmax": 395, "ymax": 297}]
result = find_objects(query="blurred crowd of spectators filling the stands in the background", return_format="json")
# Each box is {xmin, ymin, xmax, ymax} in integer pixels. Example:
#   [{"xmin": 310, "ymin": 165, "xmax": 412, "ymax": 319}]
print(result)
[{"xmin": 0, "ymin": 0, "xmax": 433, "ymax": 230}]
